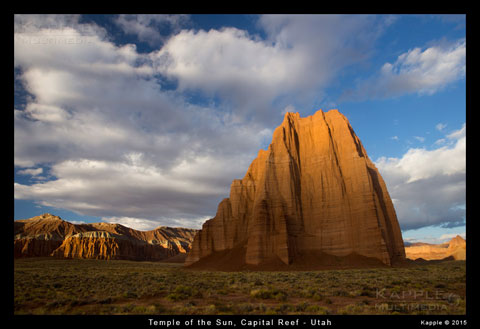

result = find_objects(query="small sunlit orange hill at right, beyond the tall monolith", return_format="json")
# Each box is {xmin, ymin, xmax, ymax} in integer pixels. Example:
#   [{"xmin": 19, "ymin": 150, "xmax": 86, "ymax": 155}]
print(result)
[{"xmin": 405, "ymin": 235, "xmax": 467, "ymax": 260}]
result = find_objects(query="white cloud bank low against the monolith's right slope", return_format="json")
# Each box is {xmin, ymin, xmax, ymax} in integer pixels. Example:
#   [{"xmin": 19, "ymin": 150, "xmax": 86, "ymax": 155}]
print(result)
[{"xmin": 375, "ymin": 125, "xmax": 466, "ymax": 230}]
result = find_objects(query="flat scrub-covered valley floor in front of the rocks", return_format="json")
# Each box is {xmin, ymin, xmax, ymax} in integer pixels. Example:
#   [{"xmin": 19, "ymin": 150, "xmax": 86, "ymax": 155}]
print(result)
[{"xmin": 14, "ymin": 258, "xmax": 466, "ymax": 315}]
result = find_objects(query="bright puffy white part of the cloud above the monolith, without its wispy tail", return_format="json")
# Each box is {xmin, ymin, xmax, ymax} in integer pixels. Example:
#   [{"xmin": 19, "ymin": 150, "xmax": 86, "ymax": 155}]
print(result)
[{"xmin": 157, "ymin": 28, "xmax": 296, "ymax": 117}]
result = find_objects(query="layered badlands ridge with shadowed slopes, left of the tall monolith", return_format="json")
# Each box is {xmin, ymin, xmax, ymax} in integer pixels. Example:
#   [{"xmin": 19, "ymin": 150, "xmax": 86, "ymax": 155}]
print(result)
[{"xmin": 14, "ymin": 214, "xmax": 197, "ymax": 261}]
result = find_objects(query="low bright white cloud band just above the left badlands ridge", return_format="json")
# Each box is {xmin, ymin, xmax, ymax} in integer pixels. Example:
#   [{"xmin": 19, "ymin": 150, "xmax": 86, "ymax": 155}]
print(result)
[{"xmin": 14, "ymin": 154, "xmax": 242, "ymax": 226}]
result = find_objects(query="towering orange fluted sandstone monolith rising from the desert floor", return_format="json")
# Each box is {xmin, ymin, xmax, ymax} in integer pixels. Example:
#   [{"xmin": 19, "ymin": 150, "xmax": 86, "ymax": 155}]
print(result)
[{"xmin": 185, "ymin": 110, "xmax": 405, "ymax": 269}]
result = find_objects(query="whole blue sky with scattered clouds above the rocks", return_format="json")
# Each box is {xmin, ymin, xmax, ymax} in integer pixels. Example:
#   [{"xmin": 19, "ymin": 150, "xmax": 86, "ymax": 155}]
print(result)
[{"xmin": 13, "ymin": 14, "xmax": 466, "ymax": 243}]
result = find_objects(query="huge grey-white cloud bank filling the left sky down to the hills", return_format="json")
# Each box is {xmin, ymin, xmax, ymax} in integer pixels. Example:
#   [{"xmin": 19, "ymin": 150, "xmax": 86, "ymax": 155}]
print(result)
[{"xmin": 14, "ymin": 16, "xmax": 268, "ymax": 226}]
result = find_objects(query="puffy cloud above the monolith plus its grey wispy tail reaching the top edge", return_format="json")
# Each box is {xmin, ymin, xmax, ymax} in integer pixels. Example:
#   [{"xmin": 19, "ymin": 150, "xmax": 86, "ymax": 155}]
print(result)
[{"xmin": 153, "ymin": 15, "xmax": 384, "ymax": 123}]
